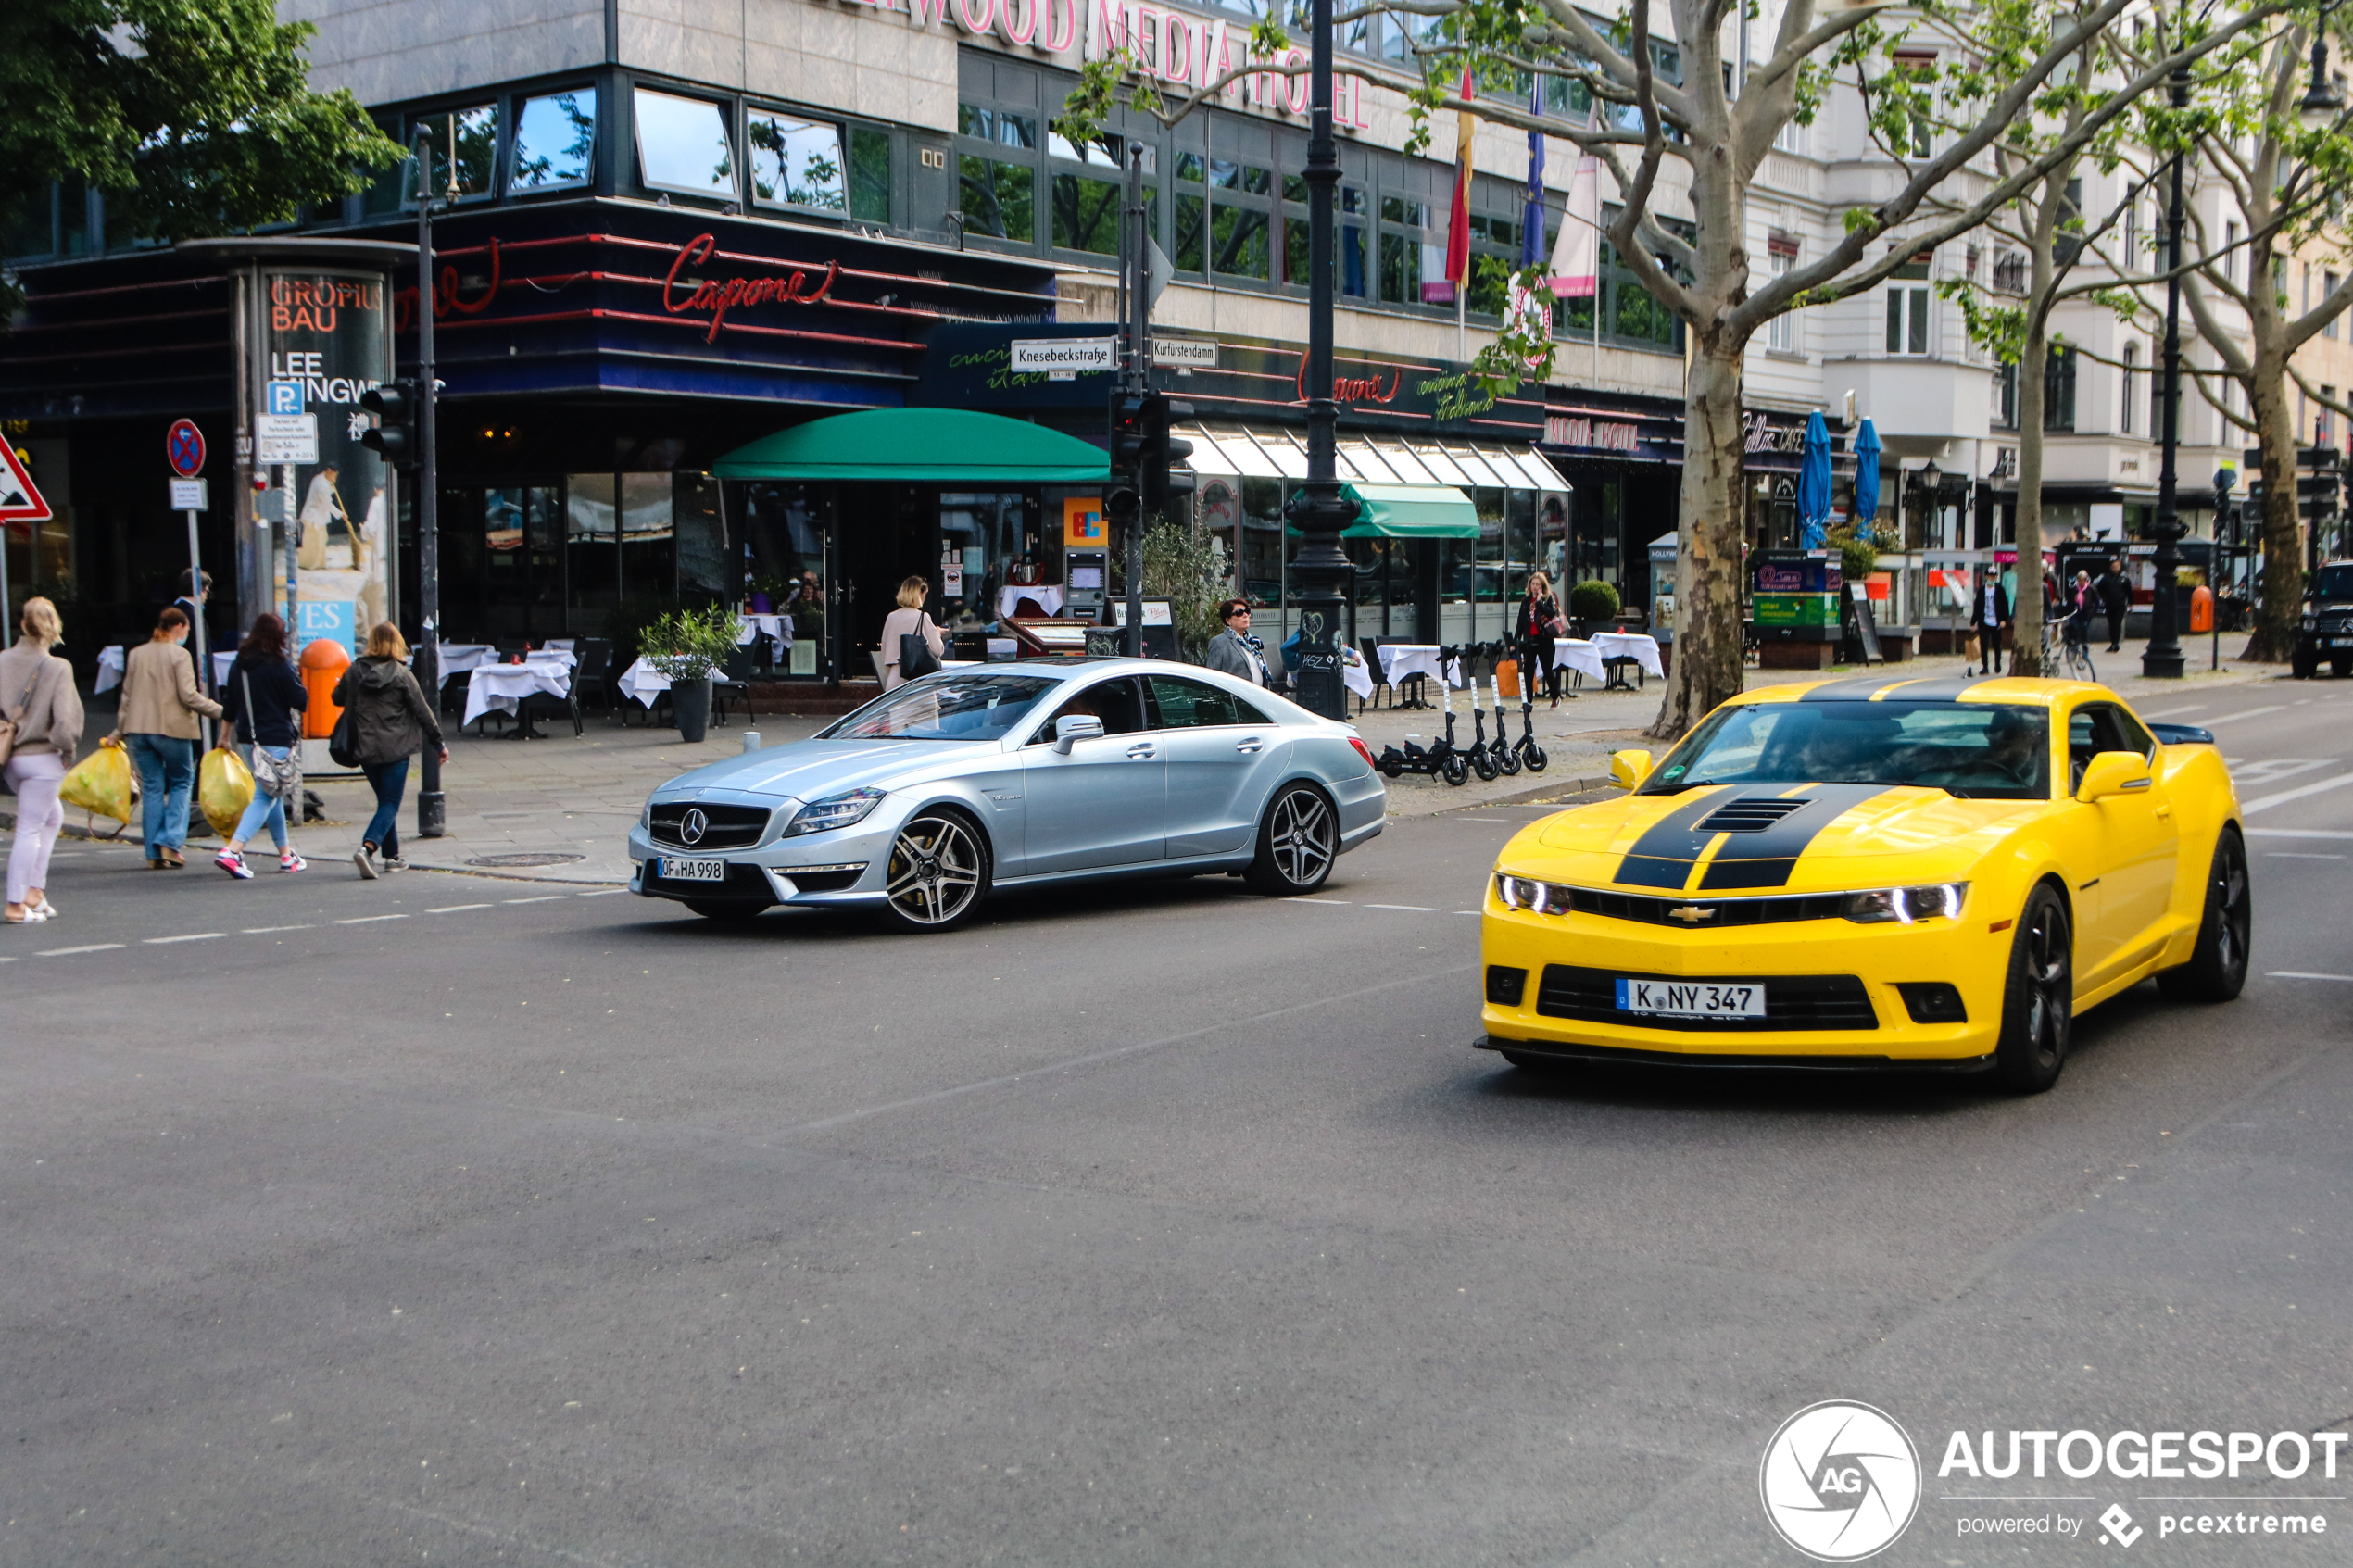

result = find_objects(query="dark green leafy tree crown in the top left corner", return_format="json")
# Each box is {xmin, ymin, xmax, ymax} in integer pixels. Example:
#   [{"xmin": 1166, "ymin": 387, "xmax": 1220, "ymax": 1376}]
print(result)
[{"xmin": 0, "ymin": 0, "xmax": 400, "ymax": 303}]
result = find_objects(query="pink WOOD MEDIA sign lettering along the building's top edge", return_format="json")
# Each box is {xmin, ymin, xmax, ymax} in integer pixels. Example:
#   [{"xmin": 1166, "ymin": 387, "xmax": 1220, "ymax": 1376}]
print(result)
[{"xmin": 845, "ymin": 0, "xmax": 1372, "ymax": 127}]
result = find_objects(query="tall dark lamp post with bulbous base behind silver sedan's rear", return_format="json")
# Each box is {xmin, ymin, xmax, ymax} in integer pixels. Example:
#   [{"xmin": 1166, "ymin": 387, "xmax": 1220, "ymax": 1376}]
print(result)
[{"xmin": 1282, "ymin": 0, "xmax": 1355, "ymax": 720}]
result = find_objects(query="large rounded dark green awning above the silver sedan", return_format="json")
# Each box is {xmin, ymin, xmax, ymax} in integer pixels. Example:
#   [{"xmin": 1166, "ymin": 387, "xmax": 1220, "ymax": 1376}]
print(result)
[{"xmin": 711, "ymin": 409, "xmax": 1111, "ymax": 489}]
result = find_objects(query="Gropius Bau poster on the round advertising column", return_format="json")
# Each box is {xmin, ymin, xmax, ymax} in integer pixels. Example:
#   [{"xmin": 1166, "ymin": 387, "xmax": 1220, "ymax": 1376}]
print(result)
[{"xmin": 257, "ymin": 268, "xmax": 396, "ymax": 654}]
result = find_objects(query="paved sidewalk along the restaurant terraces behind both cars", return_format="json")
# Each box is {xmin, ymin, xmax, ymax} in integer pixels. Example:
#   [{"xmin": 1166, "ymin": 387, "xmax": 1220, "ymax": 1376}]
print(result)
[{"xmin": 0, "ymin": 642, "xmax": 2287, "ymax": 886}]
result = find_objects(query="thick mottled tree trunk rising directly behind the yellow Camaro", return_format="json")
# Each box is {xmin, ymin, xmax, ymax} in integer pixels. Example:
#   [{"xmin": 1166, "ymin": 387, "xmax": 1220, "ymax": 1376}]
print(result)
[{"xmin": 1650, "ymin": 339, "xmax": 1746, "ymax": 741}]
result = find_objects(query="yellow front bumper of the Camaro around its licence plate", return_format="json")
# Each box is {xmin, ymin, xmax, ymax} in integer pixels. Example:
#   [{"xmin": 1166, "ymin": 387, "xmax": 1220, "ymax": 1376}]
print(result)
[{"xmin": 1480, "ymin": 879, "xmax": 2012, "ymax": 1067}]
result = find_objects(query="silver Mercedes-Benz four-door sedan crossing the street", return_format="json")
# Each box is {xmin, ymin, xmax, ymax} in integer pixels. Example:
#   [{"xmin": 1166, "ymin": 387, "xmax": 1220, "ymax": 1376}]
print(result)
[{"xmin": 628, "ymin": 659, "xmax": 1389, "ymax": 931}]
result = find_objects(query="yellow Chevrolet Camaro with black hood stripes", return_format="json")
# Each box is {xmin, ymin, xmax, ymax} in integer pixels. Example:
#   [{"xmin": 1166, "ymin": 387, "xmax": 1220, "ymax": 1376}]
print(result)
[{"xmin": 1480, "ymin": 674, "xmax": 2249, "ymax": 1091}]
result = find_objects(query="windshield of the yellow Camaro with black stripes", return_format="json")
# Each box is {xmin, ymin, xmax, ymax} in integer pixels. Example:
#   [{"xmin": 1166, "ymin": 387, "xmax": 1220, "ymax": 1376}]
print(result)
[{"xmin": 1642, "ymin": 700, "xmax": 2052, "ymax": 799}]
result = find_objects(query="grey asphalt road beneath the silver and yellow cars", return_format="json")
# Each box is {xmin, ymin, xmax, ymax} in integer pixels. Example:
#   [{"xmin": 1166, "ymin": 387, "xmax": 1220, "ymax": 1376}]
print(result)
[{"xmin": 0, "ymin": 682, "xmax": 2353, "ymax": 1568}]
